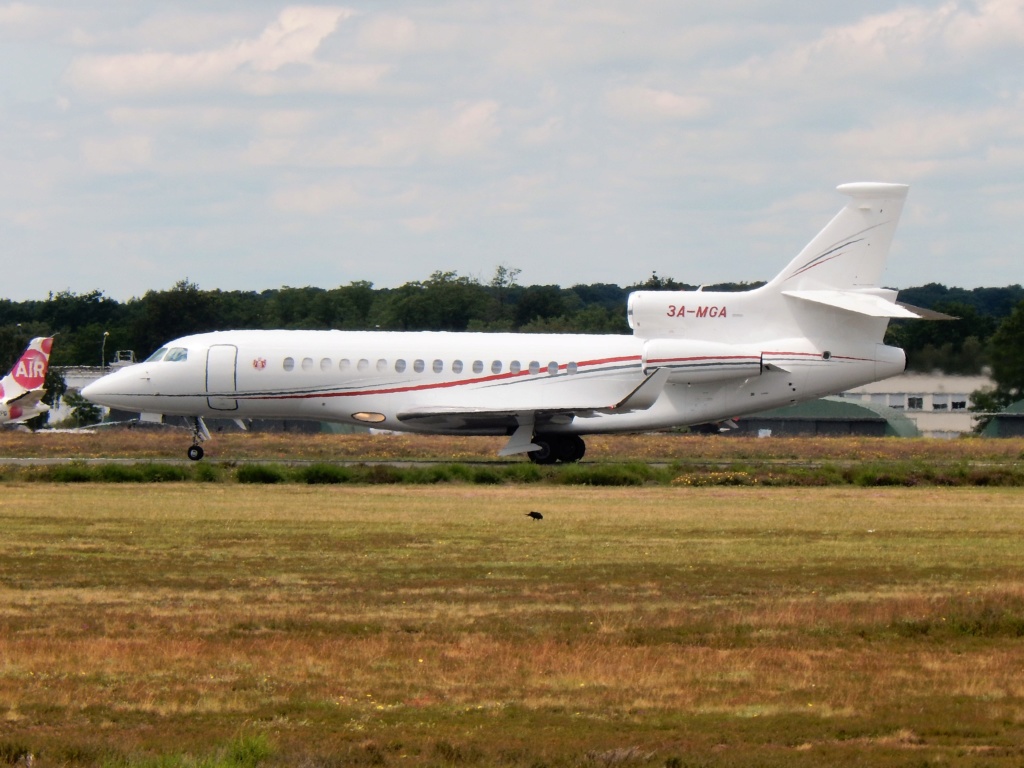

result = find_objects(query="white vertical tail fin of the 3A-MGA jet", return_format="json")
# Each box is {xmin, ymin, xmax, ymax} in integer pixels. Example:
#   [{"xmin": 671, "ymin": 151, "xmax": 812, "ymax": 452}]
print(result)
[{"xmin": 768, "ymin": 182, "xmax": 909, "ymax": 294}]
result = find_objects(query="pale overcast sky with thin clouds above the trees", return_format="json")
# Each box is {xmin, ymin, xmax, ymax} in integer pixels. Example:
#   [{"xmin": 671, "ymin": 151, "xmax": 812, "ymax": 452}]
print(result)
[{"xmin": 0, "ymin": 0, "xmax": 1024, "ymax": 300}]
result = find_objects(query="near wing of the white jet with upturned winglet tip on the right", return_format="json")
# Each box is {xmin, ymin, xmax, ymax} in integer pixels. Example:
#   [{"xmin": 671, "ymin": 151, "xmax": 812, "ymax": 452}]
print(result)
[{"xmin": 397, "ymin": 368, "xmax": 671, "ymax": 455}]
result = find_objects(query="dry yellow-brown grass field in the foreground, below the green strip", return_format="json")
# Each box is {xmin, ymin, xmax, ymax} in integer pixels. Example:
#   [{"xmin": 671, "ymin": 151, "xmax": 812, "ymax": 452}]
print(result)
[{"xmin": 0, "ymin": 483, "xmax": 1024, "ymax": 768}]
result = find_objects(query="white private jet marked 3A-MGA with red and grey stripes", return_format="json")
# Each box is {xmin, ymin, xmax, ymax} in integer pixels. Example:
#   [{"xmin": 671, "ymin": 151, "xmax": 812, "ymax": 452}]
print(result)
[{"xmin": 82, "ymin": 182, "xmax": 928, "ymax": 464}]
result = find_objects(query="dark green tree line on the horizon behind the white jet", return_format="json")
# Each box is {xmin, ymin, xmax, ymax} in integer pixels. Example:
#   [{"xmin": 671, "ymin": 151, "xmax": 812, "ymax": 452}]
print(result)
[{"xmin": 0, "ymin": 266, "xmax": 1024, "ymax": 409}]
